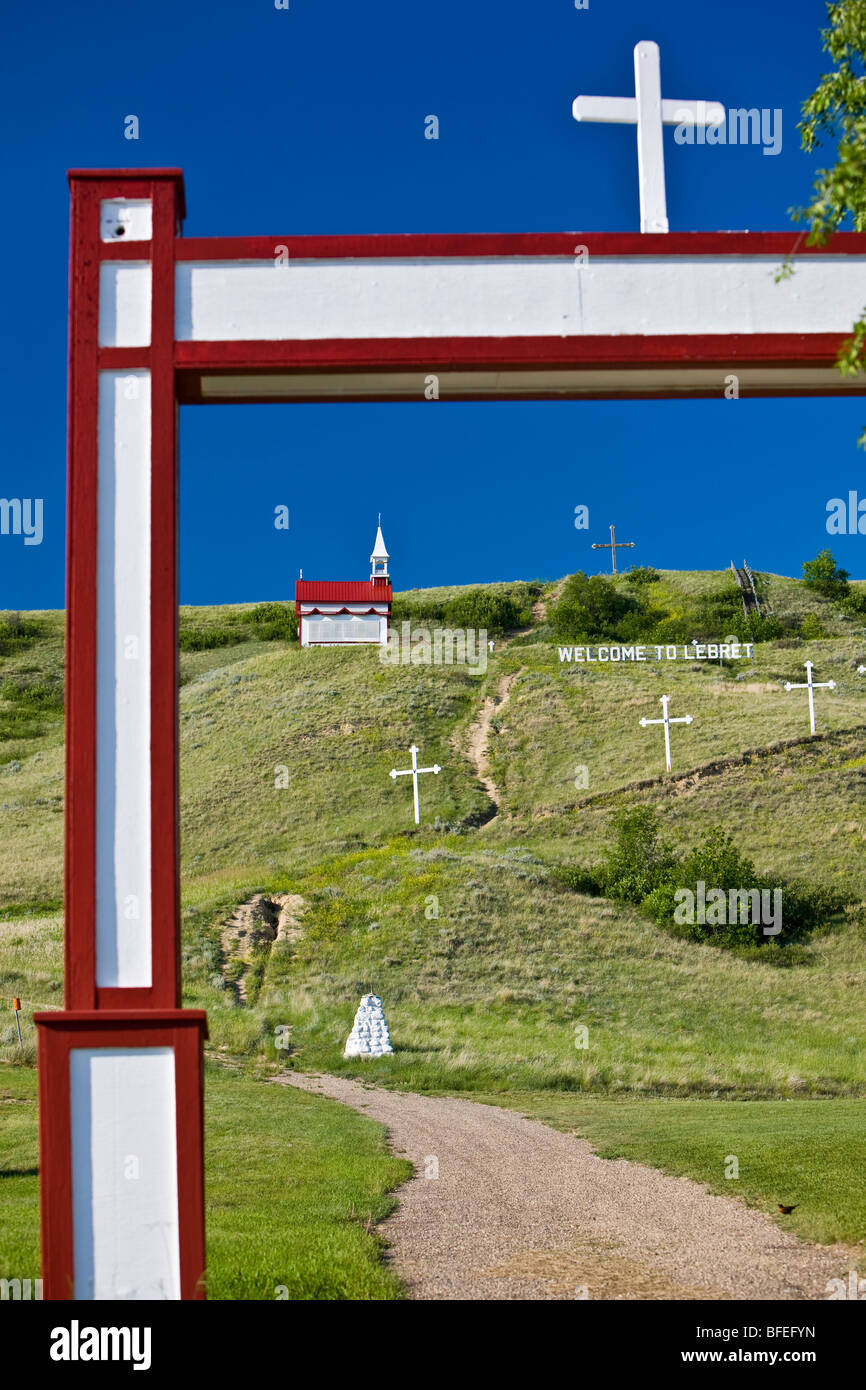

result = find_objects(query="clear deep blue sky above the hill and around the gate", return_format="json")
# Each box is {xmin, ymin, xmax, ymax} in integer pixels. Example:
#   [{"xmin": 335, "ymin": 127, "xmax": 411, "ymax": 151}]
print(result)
[{"xmin": 0, "ymin": 0, "xmax": 866, "ymax": 609}]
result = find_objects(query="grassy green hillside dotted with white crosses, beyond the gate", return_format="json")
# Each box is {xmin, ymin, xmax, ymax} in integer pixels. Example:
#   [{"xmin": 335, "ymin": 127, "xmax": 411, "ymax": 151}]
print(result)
[{"xmin": 0, "ymin": 573, "xmax": 866, "ymax": 1297}]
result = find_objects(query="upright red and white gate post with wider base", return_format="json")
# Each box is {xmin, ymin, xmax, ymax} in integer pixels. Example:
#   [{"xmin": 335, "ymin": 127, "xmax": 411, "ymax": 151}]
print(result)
[{"xmin": 35, "ymin": 170, "xmax": 207, "ymax": 1298}]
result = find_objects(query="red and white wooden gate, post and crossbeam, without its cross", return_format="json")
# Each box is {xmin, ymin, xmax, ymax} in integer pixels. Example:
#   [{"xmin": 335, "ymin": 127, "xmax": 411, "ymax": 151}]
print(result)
[{"xmin": 36, "ymin": 170, "xmax": 866, "ymax": 1298}]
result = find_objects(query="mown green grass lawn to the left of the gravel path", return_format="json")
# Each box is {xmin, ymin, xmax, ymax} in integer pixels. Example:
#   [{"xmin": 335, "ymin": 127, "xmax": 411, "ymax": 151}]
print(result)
[{"xmin": 0, "ymin": 1065, "xmax": 410, "ymax": 1300}]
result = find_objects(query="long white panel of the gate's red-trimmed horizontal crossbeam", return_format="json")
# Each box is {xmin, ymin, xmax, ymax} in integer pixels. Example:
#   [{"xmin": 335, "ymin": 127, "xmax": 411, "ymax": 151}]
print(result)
[{"xmin": 177, "ymin": 261, "xmax": 866, "ymax": 342}]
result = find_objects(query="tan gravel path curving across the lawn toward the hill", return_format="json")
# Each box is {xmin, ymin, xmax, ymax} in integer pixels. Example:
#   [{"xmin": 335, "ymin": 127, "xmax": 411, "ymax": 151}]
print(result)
[{"xmin": 281, "ymin": 1073, "xmax": 853, "ymax": 1300}]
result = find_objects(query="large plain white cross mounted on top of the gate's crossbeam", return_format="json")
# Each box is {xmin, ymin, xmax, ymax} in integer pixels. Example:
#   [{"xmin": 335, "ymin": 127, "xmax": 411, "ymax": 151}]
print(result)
[{"xmin": 571, "ymin": 39, "xmax": 726, "ymax": 232}]
